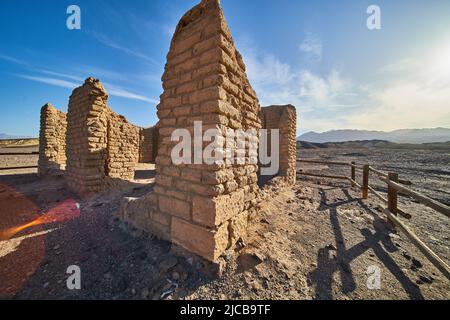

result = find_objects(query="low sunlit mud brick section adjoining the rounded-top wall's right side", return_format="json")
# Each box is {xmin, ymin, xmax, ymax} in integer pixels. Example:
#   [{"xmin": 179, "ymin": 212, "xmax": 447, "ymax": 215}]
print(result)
[{"xmin": 105, "ymin": 110, "xmax": 141, "ymax": 180}]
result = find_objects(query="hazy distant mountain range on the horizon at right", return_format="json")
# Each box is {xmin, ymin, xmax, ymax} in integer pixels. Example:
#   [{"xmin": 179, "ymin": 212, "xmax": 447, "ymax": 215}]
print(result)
[{"xmin": 297, "ymin": 128, "xmax": 450, "ymax": 143}]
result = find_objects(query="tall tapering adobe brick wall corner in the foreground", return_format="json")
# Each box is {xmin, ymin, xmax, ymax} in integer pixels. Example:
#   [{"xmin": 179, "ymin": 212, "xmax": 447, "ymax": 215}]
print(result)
[{"xmin": 152, "ymin": 0, "xmax": 261, "ymax": 260}]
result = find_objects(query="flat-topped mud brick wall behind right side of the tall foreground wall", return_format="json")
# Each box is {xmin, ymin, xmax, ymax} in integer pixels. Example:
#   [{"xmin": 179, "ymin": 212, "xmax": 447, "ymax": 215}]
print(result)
[{"xmin": 259, "ymin": 105, "xmax": 297, "ymax": 184}]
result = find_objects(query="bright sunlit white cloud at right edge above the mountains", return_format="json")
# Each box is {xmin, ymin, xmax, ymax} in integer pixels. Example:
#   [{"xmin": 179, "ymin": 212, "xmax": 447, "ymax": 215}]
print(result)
[{"xmin": 350, "ymin": 41, "xmax": 450, "ymax": 130}]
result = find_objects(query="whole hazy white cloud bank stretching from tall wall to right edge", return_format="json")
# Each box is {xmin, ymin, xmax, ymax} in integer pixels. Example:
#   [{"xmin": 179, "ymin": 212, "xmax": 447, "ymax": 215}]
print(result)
[{"xmin": 241, "ymin": 36, "xmax": 450, "ymax": 131}]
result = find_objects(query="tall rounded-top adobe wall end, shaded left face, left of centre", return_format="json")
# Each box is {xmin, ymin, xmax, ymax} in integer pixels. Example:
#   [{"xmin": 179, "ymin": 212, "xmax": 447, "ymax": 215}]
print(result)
[{"xmin": 65, "ymin": 78, "xmax": 109, "ymax": 195}]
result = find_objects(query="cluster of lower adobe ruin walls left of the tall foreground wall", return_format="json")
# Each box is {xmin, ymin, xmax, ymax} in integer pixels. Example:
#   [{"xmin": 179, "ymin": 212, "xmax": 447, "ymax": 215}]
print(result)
[{"xmin": 38, "ymin": 78, "xmax": 157, "ymax": 195}]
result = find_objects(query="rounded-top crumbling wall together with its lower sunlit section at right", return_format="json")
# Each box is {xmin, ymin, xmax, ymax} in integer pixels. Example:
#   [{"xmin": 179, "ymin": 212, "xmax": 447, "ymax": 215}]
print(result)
[{"xmin": 66, "ymin": 78, "xmax": 141, "ymax": 195}]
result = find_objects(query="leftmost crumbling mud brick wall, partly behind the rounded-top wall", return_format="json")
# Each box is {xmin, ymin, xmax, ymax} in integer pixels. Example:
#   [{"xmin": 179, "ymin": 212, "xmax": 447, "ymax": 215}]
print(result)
[{"xmin": 38, "ymin": 103, "xmax": 67, "ymax": 177}]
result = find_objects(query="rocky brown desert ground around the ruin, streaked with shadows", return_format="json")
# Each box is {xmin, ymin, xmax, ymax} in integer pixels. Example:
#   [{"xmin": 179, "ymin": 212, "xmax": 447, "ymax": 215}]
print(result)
[{"xmin": 0, "ymin": 146, "xmax": 450, "ymax": 300}]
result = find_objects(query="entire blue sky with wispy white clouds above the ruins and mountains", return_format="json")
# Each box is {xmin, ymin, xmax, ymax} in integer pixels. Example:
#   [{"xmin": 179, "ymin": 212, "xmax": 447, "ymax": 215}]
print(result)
[{"xmin": 0, "ymin": 0, "xmax": 450, "ymax": 136}]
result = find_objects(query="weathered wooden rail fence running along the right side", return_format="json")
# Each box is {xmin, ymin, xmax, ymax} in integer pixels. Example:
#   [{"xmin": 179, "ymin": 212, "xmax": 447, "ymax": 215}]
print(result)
[{"xmin": 297, "ymin": 159, "xmax": 450, "ymax": 280}]
